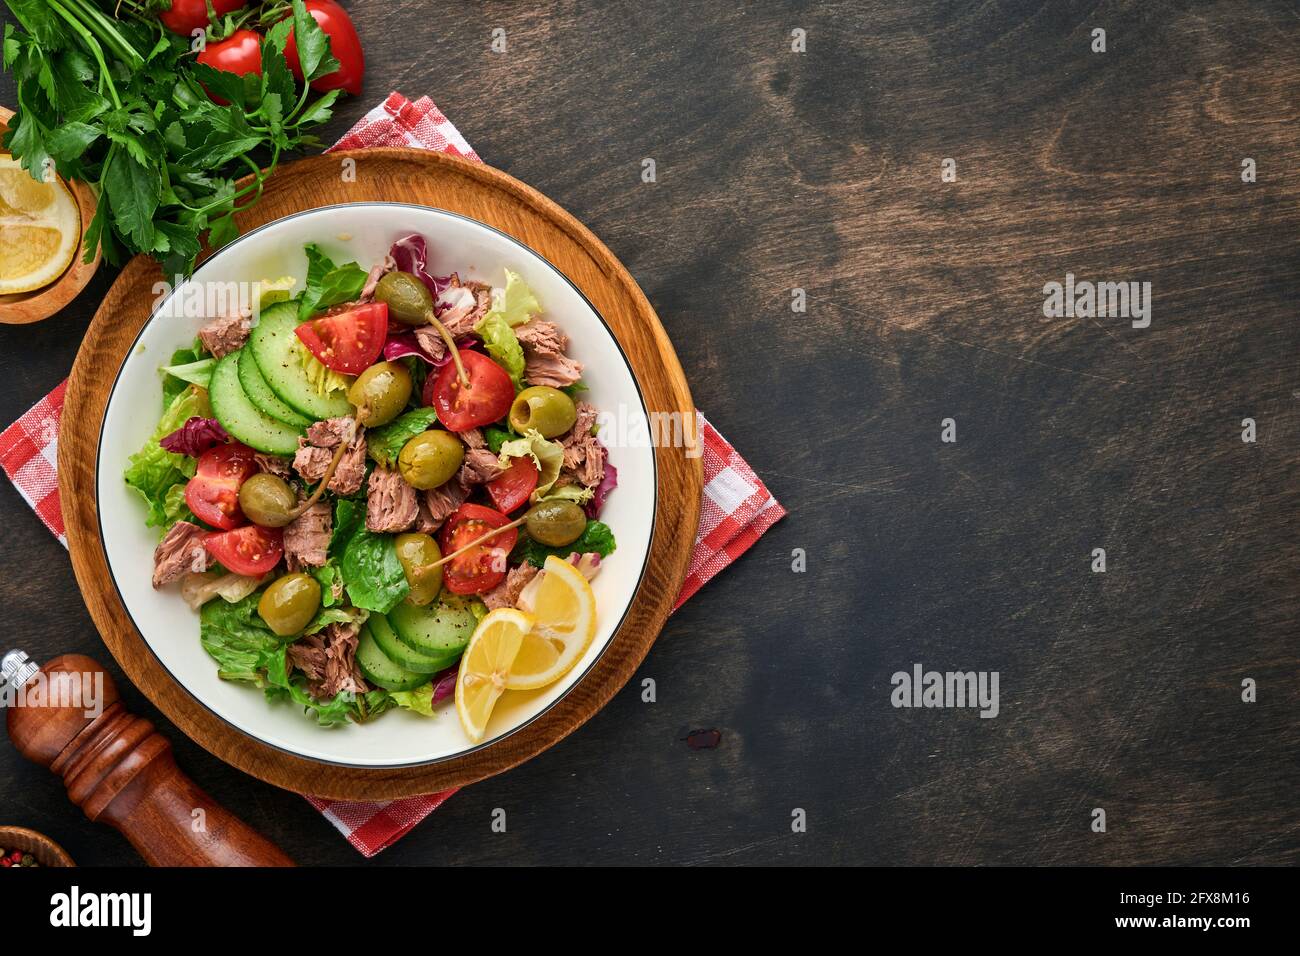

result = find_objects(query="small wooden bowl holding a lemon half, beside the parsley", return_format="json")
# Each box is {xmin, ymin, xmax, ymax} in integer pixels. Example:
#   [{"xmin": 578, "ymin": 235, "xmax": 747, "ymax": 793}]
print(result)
[{"xmin": 0, "ymin": 107, "xmax": 99, "ymax": 325}]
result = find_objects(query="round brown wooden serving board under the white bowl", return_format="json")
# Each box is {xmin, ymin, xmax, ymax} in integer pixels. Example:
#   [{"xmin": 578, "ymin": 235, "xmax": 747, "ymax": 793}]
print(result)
[{"xmin": 59, "ymin": 148, "xmax": 703, "ymax": 800}]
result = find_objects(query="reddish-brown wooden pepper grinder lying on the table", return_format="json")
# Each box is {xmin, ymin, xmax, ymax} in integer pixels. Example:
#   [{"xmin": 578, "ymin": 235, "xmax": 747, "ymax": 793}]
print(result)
[{"xmin": 0, "ymin": 650, "xmax": 294, "ymax": 866}]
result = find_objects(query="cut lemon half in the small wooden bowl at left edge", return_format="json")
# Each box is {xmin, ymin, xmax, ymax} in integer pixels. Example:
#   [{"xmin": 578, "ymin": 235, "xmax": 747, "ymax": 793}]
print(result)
[{"xmin": 0, "ymin": 153, "xmax": 81, "ymax": 295}]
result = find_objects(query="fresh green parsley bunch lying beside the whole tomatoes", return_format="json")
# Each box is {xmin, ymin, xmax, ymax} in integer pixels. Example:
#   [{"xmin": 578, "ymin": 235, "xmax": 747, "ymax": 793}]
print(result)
[{"xmin": 4, "ymin": 0, "xmax": 341, "ymax": 276}]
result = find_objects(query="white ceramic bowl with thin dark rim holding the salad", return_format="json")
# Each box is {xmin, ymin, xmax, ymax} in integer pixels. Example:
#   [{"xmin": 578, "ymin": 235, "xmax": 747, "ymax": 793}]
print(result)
[{"xmin": 96, "ymin": 203, "xmax": 655, "ymax": 767}]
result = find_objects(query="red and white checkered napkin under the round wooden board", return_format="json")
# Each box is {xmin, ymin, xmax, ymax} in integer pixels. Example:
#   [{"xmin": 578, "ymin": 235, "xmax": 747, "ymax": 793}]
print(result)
[{"xmin": 0, "ymin": 92, "xmax": 785, "ymax": 856}]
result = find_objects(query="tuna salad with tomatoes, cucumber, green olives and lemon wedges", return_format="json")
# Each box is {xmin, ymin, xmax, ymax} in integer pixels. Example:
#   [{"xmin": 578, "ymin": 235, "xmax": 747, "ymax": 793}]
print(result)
[{"xmin": 125, "ymin": 235, "xmax": 618, "ymax": 739}]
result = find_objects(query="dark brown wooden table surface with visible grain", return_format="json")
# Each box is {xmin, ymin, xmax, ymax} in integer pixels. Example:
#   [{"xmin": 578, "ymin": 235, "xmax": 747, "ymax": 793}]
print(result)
[{"xmin": 0, "ymin": 0, "xmax": 1300, "ymax": 865}]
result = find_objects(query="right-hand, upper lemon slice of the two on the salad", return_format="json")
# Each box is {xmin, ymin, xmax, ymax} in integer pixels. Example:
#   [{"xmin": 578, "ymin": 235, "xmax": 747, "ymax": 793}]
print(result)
[{"xmin": 506, "ymin": 554, "xmax": 595, "ymax": 691}]
